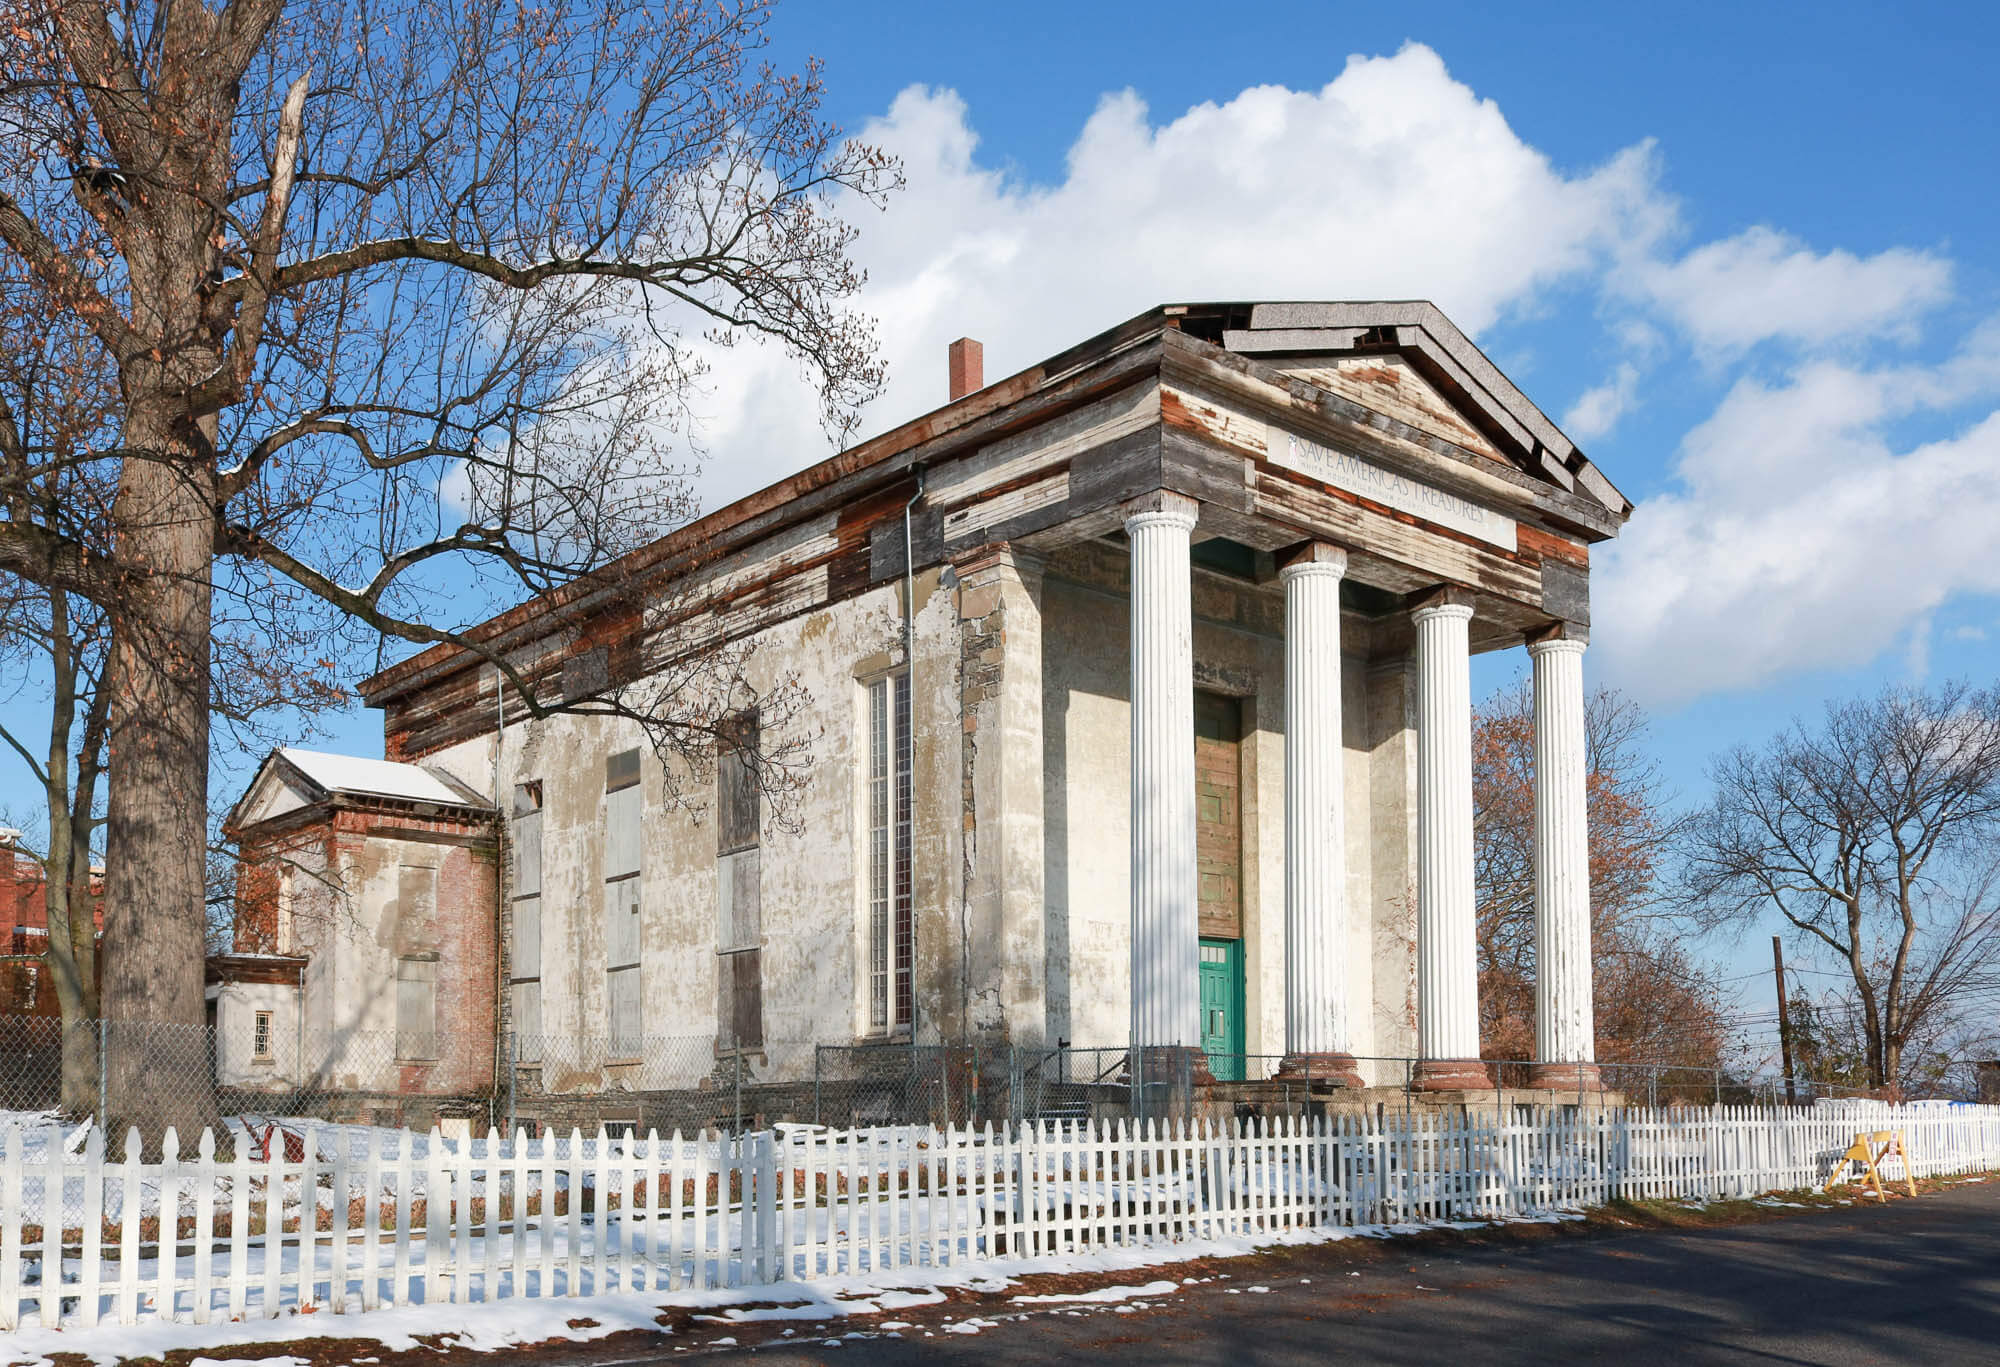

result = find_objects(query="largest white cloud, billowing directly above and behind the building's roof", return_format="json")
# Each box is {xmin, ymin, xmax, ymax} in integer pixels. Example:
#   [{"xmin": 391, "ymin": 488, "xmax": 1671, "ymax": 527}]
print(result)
[{"xmin": 680, "ymin": 46, "xmax": 1672, "ymax": 508}]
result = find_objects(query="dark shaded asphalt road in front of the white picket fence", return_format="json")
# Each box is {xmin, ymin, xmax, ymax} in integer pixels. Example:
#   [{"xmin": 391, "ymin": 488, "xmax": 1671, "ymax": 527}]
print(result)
[{"xmin": 578, "ymin": 1181, "xmax": 2000, "ymax": 1367}]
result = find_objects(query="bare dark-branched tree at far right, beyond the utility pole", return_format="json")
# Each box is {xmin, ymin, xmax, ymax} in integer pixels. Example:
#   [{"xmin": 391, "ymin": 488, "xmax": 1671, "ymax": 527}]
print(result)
[{"xmin": 1678, "ymin": 684, "xmax": 2000, "ymax": 1087}]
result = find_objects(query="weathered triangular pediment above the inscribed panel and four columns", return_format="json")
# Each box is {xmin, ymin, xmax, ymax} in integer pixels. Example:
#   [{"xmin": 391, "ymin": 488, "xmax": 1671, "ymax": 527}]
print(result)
[{"xmin": 1218, "ymin": 300, "xmax": 1632, "ymax": 522}]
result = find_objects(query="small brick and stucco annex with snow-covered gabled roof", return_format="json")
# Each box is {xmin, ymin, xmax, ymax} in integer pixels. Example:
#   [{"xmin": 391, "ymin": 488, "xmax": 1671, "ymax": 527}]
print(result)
[{"xmin": 208, "ymin": 749, "xmax": 498, "ymax": 1105}]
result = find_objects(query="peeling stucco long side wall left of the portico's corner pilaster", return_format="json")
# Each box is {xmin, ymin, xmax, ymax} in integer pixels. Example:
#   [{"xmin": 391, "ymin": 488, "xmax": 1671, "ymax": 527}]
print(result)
[{"xmin": 428, "ymin": 572, "xmax": 964, "ymax": 1091}]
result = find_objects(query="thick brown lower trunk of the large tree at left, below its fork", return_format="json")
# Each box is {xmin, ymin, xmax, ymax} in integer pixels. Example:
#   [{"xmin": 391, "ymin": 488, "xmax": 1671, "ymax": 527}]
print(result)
[{"xmin": 104, "ymin": 419, "xmax": 214, "ymax": 1137}]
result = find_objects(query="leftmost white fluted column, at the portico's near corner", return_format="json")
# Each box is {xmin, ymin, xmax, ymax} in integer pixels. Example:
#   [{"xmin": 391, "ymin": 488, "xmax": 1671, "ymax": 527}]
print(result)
[{"xmin": 1126, "ymin": 494, "xmax": 1202, "ymax": 1047}]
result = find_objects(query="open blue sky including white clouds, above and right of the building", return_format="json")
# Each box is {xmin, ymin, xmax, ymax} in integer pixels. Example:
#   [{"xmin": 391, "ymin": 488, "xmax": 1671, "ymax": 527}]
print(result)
[{"xmin": 8, "ymin": 0, "xmax": 2000, "ymax": 1055}]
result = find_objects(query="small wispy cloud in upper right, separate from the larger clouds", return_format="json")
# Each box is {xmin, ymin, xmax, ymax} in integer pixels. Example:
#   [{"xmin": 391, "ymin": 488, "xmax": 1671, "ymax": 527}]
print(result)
[{"xmin": 1626, "ymin": 228, "xmax": 1952, "ymax": 352}]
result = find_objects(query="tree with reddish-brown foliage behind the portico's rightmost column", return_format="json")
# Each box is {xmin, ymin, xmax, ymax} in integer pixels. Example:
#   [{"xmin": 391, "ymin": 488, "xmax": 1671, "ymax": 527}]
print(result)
[{"xmin": 1472, "ymin": 684, "xmax": 1730, "ymax": 1067}]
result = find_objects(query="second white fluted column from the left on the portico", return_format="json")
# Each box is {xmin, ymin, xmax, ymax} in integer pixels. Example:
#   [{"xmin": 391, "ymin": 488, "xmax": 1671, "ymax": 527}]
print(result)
[{"xmin": 1278, "ymin": 546, "xmax": 1360, "ymax": 1085}]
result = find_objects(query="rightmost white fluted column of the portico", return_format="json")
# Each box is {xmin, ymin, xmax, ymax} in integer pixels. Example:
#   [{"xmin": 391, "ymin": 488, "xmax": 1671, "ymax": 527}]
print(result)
[{"xmin": 1528, "ymin": 640, "xmax": 1598, "ymax": 1087}]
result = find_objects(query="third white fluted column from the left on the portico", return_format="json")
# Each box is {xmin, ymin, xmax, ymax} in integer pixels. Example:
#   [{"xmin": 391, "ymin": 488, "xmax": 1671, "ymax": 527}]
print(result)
[{"xmin": 1412, "ymin": 600, "xmax": 1492, "ymax": 1091}]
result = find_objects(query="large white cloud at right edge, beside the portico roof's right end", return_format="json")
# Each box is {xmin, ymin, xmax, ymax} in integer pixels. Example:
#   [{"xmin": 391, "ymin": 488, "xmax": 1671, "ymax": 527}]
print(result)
[{"xmin": 1592, "ymin": 330, "xmax": 2000, "ymax": 703}]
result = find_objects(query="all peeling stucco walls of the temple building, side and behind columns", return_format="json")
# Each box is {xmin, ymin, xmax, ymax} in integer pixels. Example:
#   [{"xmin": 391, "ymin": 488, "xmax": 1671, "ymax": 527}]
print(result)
[{"xmin": 406, "ymin": 544, "xmax": 1416, "ymax": 1089}]
